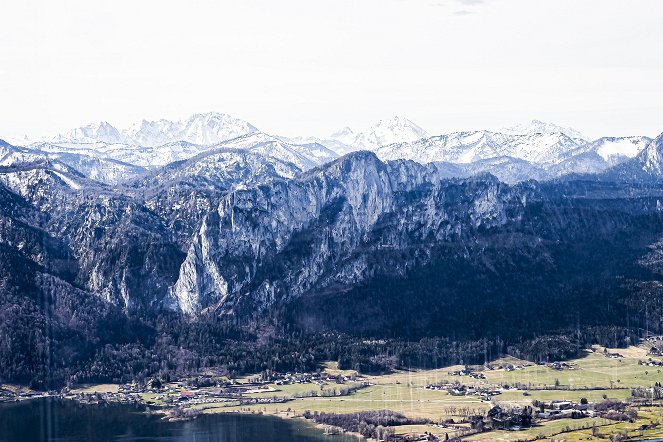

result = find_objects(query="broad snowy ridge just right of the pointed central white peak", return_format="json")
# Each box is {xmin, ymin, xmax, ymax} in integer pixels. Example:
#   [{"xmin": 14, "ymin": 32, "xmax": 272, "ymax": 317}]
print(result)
[{"xmin": 375, "ymin": 126, "xmax": 650, "ymax": 183}]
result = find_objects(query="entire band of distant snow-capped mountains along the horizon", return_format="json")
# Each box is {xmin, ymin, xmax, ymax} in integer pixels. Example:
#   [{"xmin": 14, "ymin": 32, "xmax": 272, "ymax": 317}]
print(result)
[{"xmin": 0, "ymin": 112, "xmax": 651, "ymax": 184}]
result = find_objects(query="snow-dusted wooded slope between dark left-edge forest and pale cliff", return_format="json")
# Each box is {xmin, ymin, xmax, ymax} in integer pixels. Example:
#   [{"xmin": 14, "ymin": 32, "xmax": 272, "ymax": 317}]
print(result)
[{"xmin": 0, "ymin": 161, "xmax": 183, "ymax": 311}]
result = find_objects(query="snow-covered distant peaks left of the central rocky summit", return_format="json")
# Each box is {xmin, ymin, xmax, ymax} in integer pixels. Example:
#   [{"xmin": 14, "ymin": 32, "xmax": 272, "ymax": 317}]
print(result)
[{"xmin": 24, "ymin": 112, "xmax": 337, "ymax": 178}]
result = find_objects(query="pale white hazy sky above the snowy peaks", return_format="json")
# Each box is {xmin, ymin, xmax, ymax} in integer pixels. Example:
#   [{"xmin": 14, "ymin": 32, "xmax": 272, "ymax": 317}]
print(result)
[{"xmin": 0, "ymin": 0, "xmax": 663, "ymax": 137}]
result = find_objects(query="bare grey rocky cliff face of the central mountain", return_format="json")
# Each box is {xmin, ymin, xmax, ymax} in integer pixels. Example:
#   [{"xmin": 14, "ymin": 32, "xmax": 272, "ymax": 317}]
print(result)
[{"xmin": 169, "ymin": 152, "xmax": 528, "ymax": 315}]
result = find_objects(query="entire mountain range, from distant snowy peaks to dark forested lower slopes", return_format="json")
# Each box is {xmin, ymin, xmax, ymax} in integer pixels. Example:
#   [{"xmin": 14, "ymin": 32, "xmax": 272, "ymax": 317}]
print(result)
[{"xmin": 0, "ymin": 114, "xmax": 663, "ymax": 381}]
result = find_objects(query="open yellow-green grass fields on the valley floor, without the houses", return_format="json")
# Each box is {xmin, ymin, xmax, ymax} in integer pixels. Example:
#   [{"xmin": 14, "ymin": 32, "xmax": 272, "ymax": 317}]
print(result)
[{"xmin": 196, "ymin": 347, "xmax": 663, "ymax": 441}]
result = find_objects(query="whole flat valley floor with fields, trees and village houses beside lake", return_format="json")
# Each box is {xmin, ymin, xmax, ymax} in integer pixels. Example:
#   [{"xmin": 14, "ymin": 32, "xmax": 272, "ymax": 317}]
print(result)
[{"xmin": 0, "ymin": 342, "xmax": 663, "ymax": 441}]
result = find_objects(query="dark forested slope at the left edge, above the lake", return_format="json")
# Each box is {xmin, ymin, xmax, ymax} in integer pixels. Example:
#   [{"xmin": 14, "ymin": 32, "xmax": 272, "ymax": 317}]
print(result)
[{"xmin": 0, "ymin": 180, "xmax": 143, "ymax": 389}]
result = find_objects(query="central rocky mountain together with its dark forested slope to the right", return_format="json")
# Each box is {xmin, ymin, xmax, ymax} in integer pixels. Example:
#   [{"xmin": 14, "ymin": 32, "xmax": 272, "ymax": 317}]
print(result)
[{"xmin": 168, "ymin": 152, "xmax": 663, "ymax": 336}]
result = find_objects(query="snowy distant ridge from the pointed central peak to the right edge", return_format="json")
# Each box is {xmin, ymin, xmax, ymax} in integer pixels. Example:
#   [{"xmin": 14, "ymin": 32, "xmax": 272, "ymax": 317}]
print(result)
[{"xmin": 284, "ymin": 117, "xmax": 651, "ymax": 183}]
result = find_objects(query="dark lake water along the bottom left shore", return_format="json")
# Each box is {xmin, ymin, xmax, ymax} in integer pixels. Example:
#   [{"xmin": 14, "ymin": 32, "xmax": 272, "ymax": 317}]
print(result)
[{"xmin": 0, "ymin": 399, "xmax": 358, "ymax": 442}]
